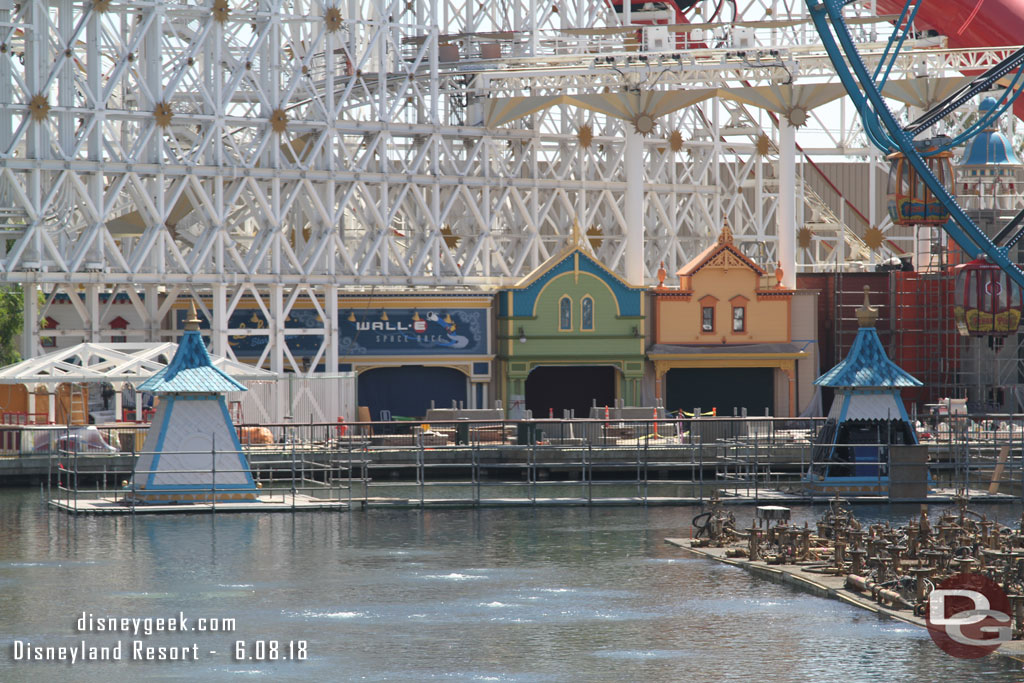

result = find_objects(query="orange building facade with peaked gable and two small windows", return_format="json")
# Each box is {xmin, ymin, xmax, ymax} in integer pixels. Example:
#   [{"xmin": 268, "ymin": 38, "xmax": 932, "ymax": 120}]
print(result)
[{"xmin": 647, "ymin": 225, "xmax": 817, "ymax": 417}]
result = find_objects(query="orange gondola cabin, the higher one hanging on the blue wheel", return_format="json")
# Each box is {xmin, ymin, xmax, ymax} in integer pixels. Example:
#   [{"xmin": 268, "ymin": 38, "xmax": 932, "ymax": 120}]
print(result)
[{"xmin": 887, "ymin": 146, "xmax": 953, "ymax": 225}]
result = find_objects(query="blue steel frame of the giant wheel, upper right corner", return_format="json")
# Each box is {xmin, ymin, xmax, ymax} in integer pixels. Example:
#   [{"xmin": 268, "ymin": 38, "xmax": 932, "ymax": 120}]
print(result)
[{"xmin": 805, "ymin": 0, "xmax": 1024, "ymax": 288}]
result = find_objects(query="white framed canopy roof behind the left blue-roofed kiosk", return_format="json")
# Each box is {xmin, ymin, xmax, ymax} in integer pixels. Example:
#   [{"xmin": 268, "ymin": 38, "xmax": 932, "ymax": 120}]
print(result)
[{"xmin": 0, "ymin": 342, "xmax": 278, "ymax": 391}]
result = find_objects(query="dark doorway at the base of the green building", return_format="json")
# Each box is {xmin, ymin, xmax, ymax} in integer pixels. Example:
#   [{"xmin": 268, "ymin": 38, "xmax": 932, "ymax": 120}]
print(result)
[{"xmin": 526, "ymin": 366, "xmax": 615, "ymax": 418}]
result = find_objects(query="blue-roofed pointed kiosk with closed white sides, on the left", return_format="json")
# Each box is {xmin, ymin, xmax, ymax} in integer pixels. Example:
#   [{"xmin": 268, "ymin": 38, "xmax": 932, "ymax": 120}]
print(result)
[{"xmin": 127, "ymin": 308, "xmax": 259, "ymax": 505}]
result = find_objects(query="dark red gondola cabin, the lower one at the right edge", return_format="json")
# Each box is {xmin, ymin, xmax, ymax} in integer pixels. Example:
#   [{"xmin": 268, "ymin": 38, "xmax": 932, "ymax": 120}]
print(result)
[{"xmin": 953, "ymin": 258, "xmax": 1021, "ymax": 337}]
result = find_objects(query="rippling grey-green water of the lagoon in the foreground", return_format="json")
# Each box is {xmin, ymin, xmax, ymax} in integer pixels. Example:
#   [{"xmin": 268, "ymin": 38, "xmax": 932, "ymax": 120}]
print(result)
[{"xmin": 0, "ymin": 490, "xmax": 1021, "ymax": 682}]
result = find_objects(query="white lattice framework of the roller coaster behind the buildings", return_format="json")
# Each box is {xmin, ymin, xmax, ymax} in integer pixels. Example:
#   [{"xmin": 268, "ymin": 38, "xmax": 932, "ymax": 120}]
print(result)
[{"xmin": 0, "ymin": 0, "xmax": 1015, "ymax": 372}]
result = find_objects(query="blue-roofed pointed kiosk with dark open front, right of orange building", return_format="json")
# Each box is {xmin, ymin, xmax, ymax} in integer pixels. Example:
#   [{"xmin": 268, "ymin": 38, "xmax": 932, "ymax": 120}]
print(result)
[{"xmin": 807, "ymin": 287, "xmax": 922, "ymax": 496}]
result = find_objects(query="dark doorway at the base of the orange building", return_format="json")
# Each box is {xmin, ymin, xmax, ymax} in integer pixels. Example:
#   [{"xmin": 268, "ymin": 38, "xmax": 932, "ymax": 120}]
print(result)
[{"xmin": 665, "ymin": 368, "xmax": 775, "ymax": 417}]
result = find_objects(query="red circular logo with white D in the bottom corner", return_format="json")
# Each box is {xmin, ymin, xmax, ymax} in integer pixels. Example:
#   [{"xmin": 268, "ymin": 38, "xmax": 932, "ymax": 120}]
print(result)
[{"xmin": 926, "ymin": 573, "xmax": 1013, "ymax": 659}]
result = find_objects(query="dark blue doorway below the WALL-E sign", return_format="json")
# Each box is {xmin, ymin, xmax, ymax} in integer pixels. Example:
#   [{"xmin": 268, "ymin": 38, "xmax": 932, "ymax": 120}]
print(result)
[{"xmin": 358, "ymin": 366, "xmax": 466, "ymax": 420}]
